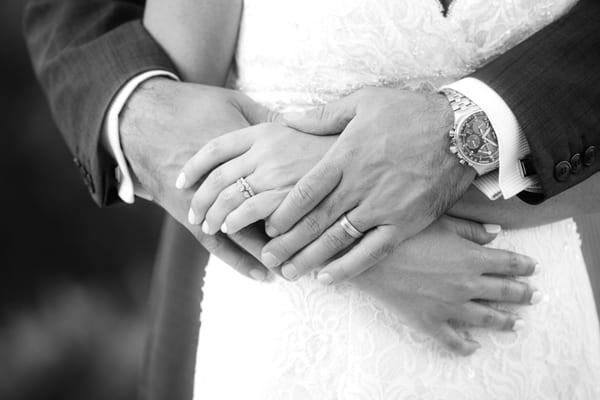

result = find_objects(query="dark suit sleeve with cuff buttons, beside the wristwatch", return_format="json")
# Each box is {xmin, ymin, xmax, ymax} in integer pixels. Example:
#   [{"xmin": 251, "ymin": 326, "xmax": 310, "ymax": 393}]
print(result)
[{"xmin": 472, "ymin": 0, "xmax": 600, "ymax": 204}]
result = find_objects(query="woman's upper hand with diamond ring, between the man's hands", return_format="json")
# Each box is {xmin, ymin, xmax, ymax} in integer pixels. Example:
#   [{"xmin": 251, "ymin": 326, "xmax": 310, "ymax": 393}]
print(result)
[{"xmin": 176, "ymin": 123, "xmax": 336, "ymax": 234}]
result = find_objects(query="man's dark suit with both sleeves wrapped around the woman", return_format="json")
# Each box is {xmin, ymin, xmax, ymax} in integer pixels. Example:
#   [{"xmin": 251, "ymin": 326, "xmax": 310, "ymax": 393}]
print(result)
[{"xmin": 25, "ymin": 0, "xmax": 600, "ymax": 399}]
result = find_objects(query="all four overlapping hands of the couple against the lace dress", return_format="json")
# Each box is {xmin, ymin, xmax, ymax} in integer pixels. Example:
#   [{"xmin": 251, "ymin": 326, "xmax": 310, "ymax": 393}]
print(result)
[{"xmin": 121, "ymin": 79, "xmax": 541, "ymax": 355}]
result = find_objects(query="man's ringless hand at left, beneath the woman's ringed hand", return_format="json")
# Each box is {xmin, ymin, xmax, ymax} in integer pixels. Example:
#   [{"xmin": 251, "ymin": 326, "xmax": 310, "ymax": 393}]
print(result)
[{"xmin": 120, "ymin": 78, "xmax": 270, "ymax": 280}]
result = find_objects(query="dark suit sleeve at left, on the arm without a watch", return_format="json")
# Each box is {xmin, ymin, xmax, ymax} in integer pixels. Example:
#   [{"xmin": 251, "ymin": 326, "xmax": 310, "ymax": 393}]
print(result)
[{"xmin": 24, "ymin": 0, "xmax": 175, "ymax": 206}]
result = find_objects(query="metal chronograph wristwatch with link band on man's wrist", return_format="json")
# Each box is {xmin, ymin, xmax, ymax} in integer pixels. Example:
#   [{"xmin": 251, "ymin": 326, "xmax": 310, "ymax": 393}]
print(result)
[{"xmin": 442, "ymin": 88, "xmax": 500, "ymax": 176}]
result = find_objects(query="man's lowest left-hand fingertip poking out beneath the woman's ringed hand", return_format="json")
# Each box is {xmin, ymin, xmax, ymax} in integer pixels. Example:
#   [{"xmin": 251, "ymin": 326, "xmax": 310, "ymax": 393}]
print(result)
[{"xmin": 196, "ymin": 231, "xmax": 269, "ymax": 281}]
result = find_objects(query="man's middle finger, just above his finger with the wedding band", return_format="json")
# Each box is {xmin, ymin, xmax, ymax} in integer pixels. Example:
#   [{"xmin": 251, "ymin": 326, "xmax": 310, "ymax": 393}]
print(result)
[{"xmin": 263, "ymin": 193, "xmax": 354, "ymax": 268}]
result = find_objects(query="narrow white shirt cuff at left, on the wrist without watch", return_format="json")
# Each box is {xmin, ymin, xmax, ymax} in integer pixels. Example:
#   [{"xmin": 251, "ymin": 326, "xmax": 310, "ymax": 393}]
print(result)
[{"xmin": 102, "ymin": 70, "xmax": 179, "ymax": 204}]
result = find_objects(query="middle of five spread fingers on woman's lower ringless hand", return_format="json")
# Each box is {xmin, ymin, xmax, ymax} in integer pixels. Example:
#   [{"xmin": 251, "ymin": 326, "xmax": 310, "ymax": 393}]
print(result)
[{"xmin": 477, "ymin": 276, "xmax": 542, "ymax": 304}]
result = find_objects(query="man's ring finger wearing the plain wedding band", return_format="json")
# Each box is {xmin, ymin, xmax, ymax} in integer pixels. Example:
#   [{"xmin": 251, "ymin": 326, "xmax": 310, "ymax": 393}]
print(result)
[{"xmin": 281, "ymin": 217, "xmax": 357, "ymax": 280}]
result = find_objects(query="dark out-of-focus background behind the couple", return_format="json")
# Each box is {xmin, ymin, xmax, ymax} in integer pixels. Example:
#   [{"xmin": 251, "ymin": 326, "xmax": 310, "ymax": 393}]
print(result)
[{"xmin": 0, "ymin": 0, "xmax": 600, "ymax": 400}]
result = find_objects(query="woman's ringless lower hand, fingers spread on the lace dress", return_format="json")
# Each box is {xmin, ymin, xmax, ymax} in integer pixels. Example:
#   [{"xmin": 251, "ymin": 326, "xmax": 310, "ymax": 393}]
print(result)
[{"xmin": 350, "ymin": 217, "xmax": 542, "ymax": 356}]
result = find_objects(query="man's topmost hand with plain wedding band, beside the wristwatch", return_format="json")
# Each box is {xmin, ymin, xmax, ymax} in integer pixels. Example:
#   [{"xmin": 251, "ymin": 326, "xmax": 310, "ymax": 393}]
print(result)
[{"xmin": 263, "ymin": 88, "xmax": 475, "ymax": 283}]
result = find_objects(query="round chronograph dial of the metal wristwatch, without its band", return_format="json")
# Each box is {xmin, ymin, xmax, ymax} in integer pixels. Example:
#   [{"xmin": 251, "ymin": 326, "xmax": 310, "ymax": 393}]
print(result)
[{"xmin": 456, "ymin": 112, "xmax": 498, "ymax": 165}]
